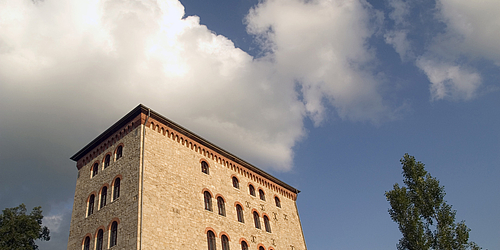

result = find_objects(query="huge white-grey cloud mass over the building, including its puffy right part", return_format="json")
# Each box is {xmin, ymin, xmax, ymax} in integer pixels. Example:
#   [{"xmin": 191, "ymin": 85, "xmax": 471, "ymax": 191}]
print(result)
[{"xmin": 0, "ymin": 0, "xmax": 390, "ymax": 170}]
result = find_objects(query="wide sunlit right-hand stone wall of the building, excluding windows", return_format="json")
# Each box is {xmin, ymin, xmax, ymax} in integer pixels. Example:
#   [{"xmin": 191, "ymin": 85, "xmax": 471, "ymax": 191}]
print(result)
[{"xmin": 142, "ymin": 125, "xmax": 306, "ymax": 250}]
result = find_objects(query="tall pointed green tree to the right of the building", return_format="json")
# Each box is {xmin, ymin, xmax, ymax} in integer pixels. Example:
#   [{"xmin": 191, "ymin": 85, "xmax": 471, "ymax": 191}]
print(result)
[{"xmin": 385, "ymin": 154, "xmax": 481, "ymax": 250}]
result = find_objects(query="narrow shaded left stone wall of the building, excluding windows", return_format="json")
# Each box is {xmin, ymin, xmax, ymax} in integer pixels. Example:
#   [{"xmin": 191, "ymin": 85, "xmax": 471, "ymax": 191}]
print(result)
[{"xmin": 68, "ymin": 127, "xmax": 141, "ymax": 250}]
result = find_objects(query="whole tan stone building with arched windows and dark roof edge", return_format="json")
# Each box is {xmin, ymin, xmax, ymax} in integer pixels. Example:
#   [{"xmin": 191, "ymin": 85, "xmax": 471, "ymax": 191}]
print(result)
[{"xmin": 68, "ymin": 105, "xmax": 307, "ymax": 250}]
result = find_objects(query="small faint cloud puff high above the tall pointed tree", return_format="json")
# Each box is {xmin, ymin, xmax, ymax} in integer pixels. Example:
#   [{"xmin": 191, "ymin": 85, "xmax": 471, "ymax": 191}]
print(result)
[{"xmin": 417, "ymin": 57, "xmax": 481, "ymax": 100}]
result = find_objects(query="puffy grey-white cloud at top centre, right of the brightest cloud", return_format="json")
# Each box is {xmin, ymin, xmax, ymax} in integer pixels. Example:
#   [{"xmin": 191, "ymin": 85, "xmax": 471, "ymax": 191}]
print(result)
[{"xmin": 247, "ymin": 0, "xmax": 390, "ymax": 124}]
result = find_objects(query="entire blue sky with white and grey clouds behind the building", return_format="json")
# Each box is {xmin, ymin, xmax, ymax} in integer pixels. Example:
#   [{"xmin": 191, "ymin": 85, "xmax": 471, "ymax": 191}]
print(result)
[{"xmin": 0, "ymin": 0, "xmax": 500, "ymax": 250}]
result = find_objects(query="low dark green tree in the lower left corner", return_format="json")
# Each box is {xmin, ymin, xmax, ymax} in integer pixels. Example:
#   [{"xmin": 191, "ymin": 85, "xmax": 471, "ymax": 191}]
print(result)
[{"xmin": 0, "ymin": 204, "xmax": 50, "ymax": 250}]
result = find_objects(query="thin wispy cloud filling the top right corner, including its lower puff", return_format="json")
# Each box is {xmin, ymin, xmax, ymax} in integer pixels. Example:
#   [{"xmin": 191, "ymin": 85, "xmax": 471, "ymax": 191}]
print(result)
[{"xmin": 385, "ymin": 0, "xmax": 500, "ymax": 100}]
